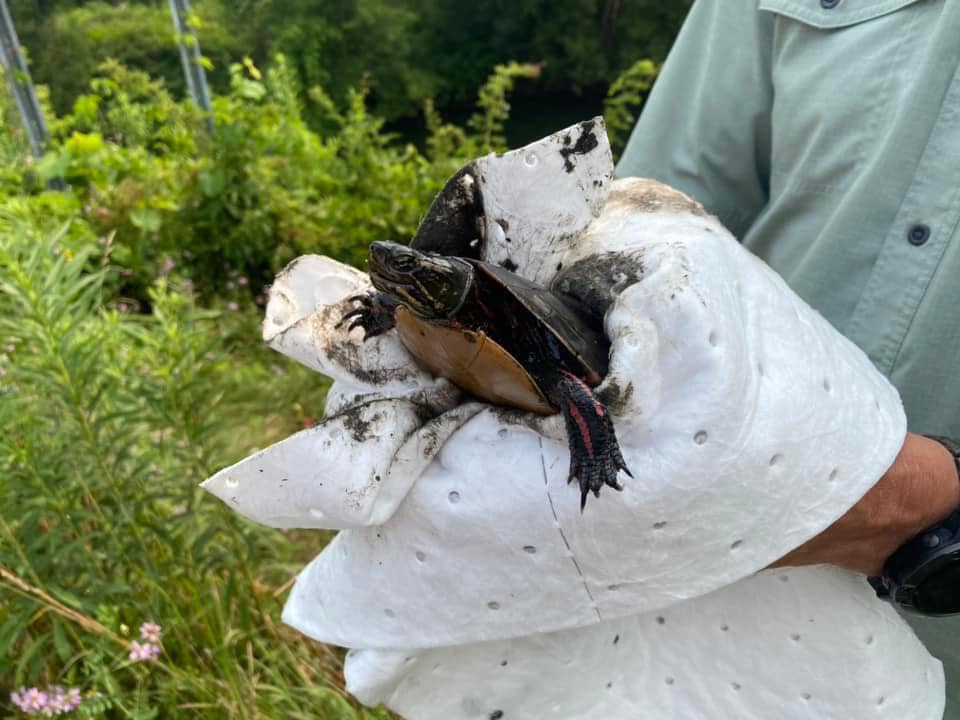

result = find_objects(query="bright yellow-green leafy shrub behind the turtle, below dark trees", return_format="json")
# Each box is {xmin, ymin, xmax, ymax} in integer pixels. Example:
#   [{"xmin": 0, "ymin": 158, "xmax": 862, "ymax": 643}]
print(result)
[{"xmin": 5, "ymin": 56, "xmax": 556, "ymax": 308}]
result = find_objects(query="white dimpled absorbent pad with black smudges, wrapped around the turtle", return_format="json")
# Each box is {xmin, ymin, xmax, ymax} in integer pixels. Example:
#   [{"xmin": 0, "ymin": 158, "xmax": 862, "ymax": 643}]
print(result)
[{"xmin": 205, "ymin": 125, "xmax": 943, "ymax": 720}]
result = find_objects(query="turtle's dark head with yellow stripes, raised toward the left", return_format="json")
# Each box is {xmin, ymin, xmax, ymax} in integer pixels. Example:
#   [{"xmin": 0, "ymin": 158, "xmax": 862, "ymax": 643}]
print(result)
[{"xmin": 369, "ymin": 242, "xmax": 473, "ymax": 318}]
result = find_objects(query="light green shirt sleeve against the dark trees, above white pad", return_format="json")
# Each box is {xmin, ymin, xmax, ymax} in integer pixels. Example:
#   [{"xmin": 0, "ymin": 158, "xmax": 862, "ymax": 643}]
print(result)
[{"xmin": 617, "ymin": 0, "xmax": 773, "ymax": 237}]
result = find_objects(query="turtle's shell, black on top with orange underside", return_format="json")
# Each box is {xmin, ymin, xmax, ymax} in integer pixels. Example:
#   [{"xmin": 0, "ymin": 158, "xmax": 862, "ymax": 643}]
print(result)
[{"xmin": 394, "ymin": 260, "xmax": 610, "ymax": 415}]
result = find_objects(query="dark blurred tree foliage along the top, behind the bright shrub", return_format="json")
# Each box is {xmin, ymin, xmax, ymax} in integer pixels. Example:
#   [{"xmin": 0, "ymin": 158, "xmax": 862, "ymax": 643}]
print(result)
[{"xmin": 5, "ymin": 0, "xmax": 690, "ymax": 127}]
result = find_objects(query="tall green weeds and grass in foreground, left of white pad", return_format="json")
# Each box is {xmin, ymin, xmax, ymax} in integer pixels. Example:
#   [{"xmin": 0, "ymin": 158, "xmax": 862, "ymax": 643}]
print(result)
[{"xmin": 0, "ymin": 218, "xmax": 372, "ymax": 718}]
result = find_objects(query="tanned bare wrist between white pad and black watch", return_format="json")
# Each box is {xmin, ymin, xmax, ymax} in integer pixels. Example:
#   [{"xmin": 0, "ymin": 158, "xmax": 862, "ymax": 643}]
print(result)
[{"xmin": 773, "ymin": 433, "xmax": 960, "ymax": 575}]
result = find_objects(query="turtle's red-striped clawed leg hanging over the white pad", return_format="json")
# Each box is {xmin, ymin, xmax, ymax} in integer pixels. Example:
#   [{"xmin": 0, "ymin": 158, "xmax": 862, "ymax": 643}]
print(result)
[{"xmin": 547, "ymin": 370, "xmax": 633, "ymax": 511}]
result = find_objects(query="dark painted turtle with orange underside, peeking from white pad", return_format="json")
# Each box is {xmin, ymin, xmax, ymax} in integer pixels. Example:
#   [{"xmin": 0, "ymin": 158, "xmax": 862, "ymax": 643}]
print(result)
[{"xmin": 341, "ymin": 242, "xmax": 632, "ymax": 510}]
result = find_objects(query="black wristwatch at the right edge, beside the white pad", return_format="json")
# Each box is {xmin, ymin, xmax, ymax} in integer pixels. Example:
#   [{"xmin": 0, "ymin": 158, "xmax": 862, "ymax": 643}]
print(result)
[{"xmin": 867, "ymin": 435, "xmax": 960, "ymax": 617}]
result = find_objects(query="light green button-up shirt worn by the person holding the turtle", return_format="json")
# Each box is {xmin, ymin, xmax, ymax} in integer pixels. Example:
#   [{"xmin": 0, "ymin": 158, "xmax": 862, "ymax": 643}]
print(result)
[{"xmin": 617, "ymin": 0, "xmax": 960, "ymax": 720}]
